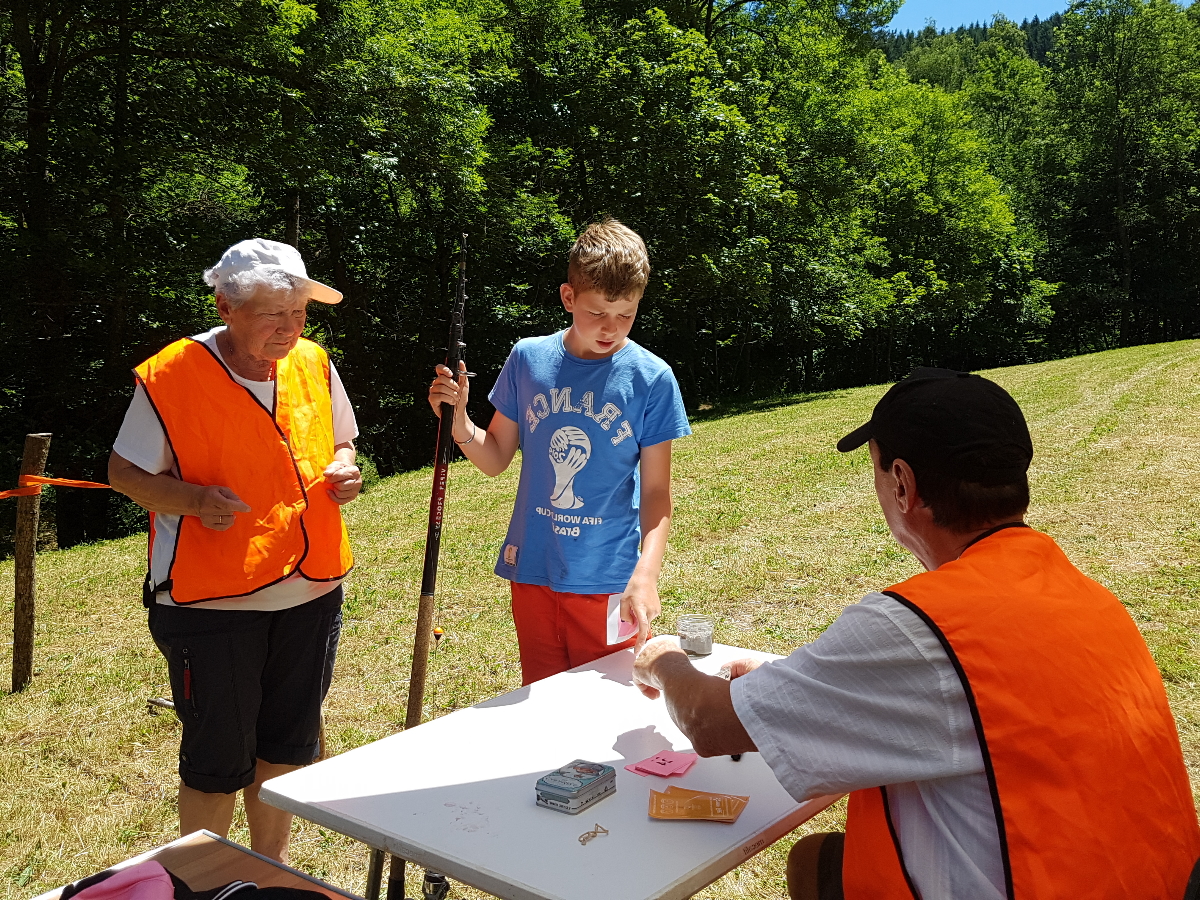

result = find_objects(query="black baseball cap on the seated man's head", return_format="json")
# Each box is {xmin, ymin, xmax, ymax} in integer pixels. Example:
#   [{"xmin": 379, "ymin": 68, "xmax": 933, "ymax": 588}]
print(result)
[{"xmin": 838, "ymin": 367, "xmax": 1033, "ymax": 485}]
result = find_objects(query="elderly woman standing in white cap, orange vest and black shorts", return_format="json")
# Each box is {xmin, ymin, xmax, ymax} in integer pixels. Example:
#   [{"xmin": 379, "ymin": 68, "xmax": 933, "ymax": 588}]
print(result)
[{"xmin": 108, "ymin": 239, "xmax": 362, "ymax": 862}]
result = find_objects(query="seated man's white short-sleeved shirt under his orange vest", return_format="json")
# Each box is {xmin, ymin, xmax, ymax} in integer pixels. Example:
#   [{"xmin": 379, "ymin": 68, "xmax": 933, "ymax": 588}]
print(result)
[{"xmin": 731, "ymin": 594, "xmax": 1004, "ymax": 900}]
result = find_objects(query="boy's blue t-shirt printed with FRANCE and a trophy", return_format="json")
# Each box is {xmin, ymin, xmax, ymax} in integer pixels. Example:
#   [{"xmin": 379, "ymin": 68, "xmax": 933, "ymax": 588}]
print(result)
[{"xmin": 488, "ymin": 332, "xmax": 691, "ymax": 594}]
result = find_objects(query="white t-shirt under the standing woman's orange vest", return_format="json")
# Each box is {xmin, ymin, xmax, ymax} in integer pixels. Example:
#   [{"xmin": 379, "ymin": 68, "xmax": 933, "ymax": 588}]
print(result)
[{"xmin": 113, "ymin": 325, "xmax": 359, "ymax": 611}]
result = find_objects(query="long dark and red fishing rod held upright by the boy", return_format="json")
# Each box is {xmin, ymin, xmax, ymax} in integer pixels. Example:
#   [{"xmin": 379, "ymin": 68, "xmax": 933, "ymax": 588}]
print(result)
[{"xmin": 404, "ymin": 234, "xmax": 467, "ymax": 731}]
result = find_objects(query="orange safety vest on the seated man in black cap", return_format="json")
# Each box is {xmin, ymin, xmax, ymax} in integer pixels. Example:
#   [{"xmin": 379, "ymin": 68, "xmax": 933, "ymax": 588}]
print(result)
[{"xmin": 842, "ymin": 527, "xmax": 1200, "ymax": 900}]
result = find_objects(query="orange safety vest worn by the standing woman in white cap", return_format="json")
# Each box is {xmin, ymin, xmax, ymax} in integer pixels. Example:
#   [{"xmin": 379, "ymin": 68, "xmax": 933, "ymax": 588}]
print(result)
[{"xmin": 134, "ymin": 337, "xmax": 354, "ymax": 604}]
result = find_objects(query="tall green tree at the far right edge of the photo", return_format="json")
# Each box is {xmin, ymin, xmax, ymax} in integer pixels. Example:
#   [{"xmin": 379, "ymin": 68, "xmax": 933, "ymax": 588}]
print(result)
[{"xmin": 1040, "ymin": 0, "xmax": 1200, "ymax": 350}]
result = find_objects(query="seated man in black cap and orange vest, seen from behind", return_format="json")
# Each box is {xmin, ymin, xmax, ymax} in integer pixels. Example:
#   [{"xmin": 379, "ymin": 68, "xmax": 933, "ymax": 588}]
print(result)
[{"xmin": 634, "ymin": 368, "xmax": 1200, "ymax": 900}]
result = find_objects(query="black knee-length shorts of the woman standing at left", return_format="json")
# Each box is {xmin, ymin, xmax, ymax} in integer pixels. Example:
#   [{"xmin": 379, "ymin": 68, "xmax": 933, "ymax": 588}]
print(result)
[{"xmin": 150, "ymin": 586, "xmax": 342, "ymax": 793}]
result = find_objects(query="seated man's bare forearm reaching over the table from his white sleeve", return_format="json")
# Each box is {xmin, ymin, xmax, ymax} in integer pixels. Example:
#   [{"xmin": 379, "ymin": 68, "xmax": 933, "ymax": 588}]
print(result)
[{"xmin": 654, "ymin": 653, "xmax": 757, "ymax": 756}]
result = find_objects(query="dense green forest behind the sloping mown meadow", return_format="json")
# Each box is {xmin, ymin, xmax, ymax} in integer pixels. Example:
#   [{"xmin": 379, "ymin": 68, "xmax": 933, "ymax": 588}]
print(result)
[{"xmin": 0, "ymin": 0, "xmax": 1200, "ymax": 546}]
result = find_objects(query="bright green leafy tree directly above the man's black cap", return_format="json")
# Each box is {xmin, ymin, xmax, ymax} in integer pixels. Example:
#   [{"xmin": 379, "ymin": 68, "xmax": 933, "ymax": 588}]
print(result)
[{"xmin": 825, "ymin": 68, "xmax": 1048, "ymax": 379}]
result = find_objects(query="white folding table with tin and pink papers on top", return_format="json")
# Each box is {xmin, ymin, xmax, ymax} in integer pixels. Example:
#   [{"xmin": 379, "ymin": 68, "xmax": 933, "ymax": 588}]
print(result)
[{"xmin": 260, "ymin": 644, "xmax": 839, "ymax": 900}]
